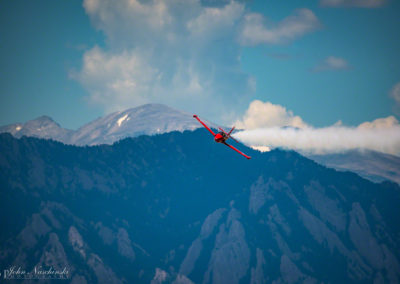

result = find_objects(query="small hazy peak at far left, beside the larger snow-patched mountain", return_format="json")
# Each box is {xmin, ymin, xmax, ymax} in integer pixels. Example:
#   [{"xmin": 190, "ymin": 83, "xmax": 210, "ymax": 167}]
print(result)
[{"xmin": 0, "ymin": 115, "xmax": 73, "ymax": 142}]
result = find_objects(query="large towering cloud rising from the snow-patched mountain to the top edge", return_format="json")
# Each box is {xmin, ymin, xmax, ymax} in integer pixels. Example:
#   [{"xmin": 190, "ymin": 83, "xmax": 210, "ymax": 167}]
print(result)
[{"xmin": 78, "ymin": 0, "xmax": 256, "ymax": 119}]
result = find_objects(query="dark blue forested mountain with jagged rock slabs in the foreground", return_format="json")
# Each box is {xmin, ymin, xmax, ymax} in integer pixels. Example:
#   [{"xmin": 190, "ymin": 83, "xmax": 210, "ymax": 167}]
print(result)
[{"xmin": 0, "ymin": 130, "xmax": 400, "ymax": 283}]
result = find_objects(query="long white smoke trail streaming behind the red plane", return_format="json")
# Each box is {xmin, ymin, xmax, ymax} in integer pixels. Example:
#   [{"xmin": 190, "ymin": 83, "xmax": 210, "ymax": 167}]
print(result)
[{"xmin": 233, "ymin": 124, "xmax": 400, "ymax": 156}]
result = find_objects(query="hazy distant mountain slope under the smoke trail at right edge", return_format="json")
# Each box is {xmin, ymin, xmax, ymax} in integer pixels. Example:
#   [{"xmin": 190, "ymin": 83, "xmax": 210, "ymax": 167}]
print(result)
[{"xmin": 308, "ymin": 150, "xmax": 400, "ymax": 184}]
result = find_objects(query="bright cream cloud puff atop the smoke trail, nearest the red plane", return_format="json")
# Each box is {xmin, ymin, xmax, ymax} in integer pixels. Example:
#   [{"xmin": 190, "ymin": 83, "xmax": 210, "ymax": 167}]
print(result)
[{"xmin": 235, "ymin": 100, "xmax": 307, "ymax": 129}]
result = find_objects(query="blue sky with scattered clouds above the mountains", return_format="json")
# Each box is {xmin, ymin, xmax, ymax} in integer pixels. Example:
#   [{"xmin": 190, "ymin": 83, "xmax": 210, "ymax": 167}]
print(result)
[{"xmin": 0, "ymin": 0, "xmax": 400, "ymax": 129}]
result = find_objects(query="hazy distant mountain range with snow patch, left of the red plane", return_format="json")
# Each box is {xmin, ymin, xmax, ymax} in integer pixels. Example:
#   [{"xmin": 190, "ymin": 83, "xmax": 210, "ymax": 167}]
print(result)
[{"xmin": 0, "ymin": 104, "xmax": 218, "ymax": 145}]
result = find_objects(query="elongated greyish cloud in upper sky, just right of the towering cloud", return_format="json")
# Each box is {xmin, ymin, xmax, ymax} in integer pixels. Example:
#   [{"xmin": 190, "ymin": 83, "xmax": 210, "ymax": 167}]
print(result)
[{"xmin": 239, "ymin": 8, "xmax": 321, "ymax": 45}]
